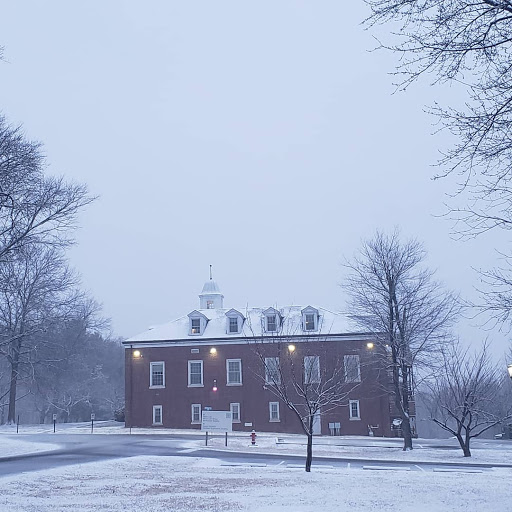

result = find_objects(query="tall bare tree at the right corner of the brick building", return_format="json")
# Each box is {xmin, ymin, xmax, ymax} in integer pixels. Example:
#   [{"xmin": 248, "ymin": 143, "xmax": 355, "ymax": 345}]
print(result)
[{"xmin": 342, "ymin": 230, "xmax": 460, "ymax": 450}]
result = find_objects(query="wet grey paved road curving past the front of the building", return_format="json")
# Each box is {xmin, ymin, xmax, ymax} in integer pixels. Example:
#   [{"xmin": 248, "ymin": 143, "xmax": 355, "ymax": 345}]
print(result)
[{"xmin": 0, "ymin": 434, "xmax": 504, "ymax": 476}]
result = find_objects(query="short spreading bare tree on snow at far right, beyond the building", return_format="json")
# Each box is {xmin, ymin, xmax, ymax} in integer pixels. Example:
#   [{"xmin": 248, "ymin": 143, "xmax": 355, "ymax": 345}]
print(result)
[{"xmin": 429, "ymin": 343, "xmax": 512, "ymax": 457}]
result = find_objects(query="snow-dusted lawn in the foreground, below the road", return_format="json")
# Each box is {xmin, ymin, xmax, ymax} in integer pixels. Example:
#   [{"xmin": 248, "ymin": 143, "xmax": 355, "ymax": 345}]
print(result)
[{"xmin": 0, "ymin": 457, "xmax": 512, "ymax": 512}]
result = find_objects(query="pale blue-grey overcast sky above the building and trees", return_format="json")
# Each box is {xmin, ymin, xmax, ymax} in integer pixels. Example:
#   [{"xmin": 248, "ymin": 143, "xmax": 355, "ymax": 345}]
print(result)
[{"xmin": 0, "ymin": 0, "xmax": 506, "ymax": 351}]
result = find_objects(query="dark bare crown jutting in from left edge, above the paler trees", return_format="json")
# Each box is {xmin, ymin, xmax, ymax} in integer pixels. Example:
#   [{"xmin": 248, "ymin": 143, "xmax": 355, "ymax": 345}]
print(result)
[{"xmin": 0, "ymin": 116, "xmax": 94, "ymax": 262}]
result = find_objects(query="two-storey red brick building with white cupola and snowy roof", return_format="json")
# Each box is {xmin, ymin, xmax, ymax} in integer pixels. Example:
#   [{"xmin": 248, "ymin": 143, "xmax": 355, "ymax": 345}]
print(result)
[{"xmin": 124, "ymin": 279, "xmax": 408, "ymax": 436}]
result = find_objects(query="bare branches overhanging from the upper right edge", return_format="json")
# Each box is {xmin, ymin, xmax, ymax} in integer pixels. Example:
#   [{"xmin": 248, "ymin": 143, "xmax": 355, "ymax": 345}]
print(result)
[{"xmin": 365, "ymin": 0, "xmax": 512, "ymax": 323}]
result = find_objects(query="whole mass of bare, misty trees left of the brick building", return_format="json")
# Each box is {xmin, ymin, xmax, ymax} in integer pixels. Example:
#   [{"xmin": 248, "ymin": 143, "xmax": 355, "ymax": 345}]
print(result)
[{"xmin": 0, "ymin": 116, "xmax": 124, "ymax": 423}]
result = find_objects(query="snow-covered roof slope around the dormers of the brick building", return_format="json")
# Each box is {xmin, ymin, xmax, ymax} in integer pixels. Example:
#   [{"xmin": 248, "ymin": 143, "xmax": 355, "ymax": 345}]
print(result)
[{"xmin": 125, "ymin": 306, "xmax": 368, "ymax": 343}]
